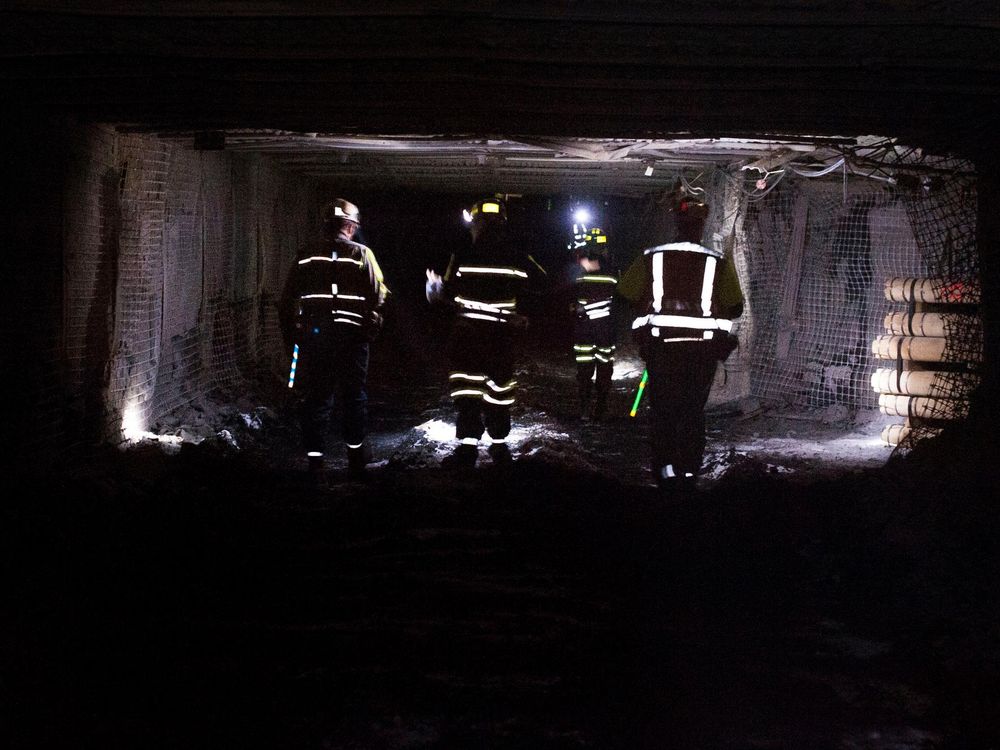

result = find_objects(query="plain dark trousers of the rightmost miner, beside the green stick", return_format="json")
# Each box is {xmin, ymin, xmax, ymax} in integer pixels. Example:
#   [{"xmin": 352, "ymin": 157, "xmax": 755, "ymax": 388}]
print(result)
[{"xmin": 643, "ymin": 339, "xmax": 719, "ymax": 477}]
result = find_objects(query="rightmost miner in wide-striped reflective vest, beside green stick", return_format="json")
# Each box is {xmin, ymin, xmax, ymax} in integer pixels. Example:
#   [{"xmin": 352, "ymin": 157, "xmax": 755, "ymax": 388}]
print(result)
[{"xmin": 619, "ymin": 191, "xmax": 743, "ymax": 490}]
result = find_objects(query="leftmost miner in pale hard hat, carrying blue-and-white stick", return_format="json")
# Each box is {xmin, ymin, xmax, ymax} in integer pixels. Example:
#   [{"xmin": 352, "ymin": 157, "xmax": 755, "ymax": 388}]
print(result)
[{"xmin": 283, "ymin": 198, "xmax": 389, "ymax": 477}]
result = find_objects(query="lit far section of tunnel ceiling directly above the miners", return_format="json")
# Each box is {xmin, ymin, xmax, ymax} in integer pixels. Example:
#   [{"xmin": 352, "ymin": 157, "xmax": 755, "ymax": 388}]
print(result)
[{"xmin": 141, "ymin": 128, "xmax": 868, "ymax": 195}]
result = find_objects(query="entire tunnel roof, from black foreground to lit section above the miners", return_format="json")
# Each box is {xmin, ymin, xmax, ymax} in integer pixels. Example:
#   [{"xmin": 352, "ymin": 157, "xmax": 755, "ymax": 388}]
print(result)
[{"xmin": 0, "ymin": 0, "xmax": 1000, "ymax": 192}]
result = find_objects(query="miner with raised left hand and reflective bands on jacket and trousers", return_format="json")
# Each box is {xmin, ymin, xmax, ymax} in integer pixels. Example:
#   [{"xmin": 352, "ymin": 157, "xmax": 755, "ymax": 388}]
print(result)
[{"xmin": 426, "ymin": 198, "xmax": 530, "ymax": 466}]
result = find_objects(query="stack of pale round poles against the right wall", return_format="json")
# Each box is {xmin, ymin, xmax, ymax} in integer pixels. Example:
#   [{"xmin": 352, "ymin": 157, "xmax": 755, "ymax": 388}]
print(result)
[{"xmin": 871, "ymin": 278, "xmax": 983, "ymax": 445}]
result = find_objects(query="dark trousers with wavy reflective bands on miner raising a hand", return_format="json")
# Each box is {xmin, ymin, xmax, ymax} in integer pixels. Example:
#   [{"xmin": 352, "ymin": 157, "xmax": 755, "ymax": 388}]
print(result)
[{"xmin": 449, "ymin": 319, "xmax": 519, "ymax": 441}]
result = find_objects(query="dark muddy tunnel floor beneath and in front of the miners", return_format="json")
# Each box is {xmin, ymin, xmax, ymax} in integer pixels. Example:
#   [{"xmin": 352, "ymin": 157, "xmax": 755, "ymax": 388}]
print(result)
[{"xmin": 0, "ymin": 342, "xmax": 1000, "ymax": 750}]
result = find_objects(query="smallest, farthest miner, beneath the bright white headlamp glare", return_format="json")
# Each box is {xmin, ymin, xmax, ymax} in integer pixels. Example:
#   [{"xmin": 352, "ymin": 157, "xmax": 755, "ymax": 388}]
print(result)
[{"xmin": 564, "ymin": 208, "xmax": 618, "ymax": 419}]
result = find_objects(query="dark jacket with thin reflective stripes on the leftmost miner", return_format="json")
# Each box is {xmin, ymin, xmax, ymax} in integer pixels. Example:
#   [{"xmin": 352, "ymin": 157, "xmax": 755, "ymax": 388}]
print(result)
[{"xmin": 296, "ymin": 238, "xmax": 389, "ymax": 333}]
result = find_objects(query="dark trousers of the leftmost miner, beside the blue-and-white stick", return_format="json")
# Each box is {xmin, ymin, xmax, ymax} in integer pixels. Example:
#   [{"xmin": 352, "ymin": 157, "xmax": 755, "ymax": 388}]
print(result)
[{"xmin": 294, "ymin": 331, "xmax": 368, "ymax": 453}]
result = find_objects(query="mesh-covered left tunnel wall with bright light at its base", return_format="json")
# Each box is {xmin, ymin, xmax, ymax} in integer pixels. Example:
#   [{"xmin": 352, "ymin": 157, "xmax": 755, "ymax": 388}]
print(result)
[{"xmin": 16, "ymin": 125, "xmax": 319, "ymax": 464}]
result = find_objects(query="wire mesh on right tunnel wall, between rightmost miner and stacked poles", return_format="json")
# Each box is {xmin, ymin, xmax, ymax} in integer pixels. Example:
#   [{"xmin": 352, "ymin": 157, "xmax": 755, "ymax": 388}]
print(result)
[{"xmin": 737, "ymin": 178, "xmax": 929, "ymax": 409}]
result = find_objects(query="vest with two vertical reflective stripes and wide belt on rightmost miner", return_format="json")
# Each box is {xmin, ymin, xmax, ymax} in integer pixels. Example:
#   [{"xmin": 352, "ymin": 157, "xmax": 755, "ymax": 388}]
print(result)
[{"xmin": 632, "ymin": 242, "xmax": 742, "ymax": 342}]
